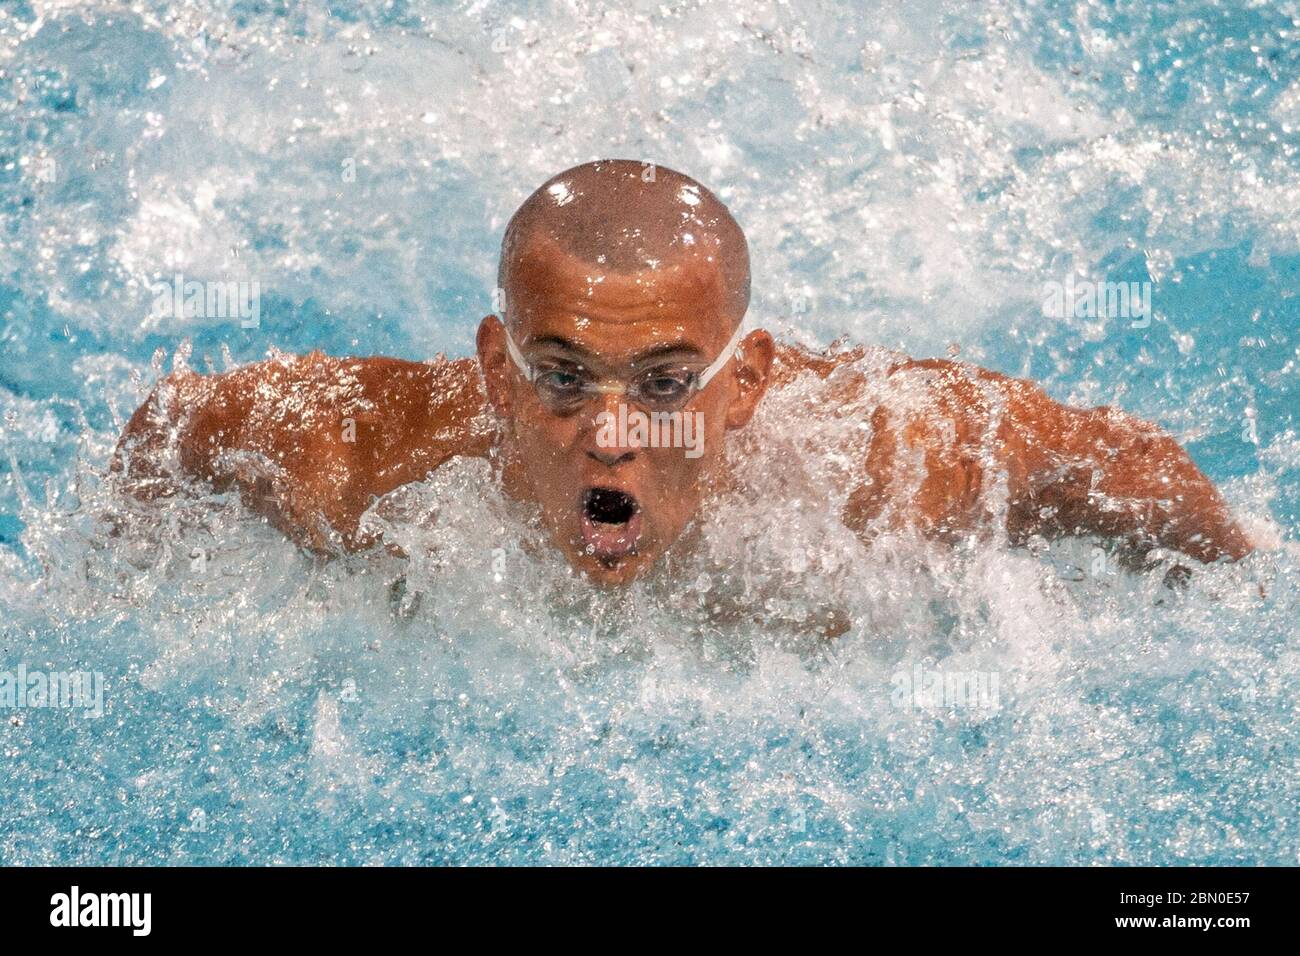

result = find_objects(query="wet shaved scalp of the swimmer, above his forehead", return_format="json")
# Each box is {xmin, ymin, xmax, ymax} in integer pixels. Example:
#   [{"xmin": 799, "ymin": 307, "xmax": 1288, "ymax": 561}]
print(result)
[{"xmin": 497, "ymin": 160, "xmax": 749, "ymax": 325}]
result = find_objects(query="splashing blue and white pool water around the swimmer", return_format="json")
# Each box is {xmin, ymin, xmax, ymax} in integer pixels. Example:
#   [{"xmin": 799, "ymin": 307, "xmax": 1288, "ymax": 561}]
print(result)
[{"xmin": 0, "ymin": 0, "xmax": 1300, "ymax": 865}]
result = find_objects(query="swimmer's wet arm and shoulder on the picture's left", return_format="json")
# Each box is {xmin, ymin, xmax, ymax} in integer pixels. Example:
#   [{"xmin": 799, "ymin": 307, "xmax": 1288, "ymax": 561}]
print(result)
[{"xmin": 112, "ymin": 352, "xmax": 486, "ymax": 553}]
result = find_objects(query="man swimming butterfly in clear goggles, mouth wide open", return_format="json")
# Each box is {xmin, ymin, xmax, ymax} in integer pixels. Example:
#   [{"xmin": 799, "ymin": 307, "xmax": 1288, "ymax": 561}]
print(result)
[{"xmin": 112, "ymin": 160, "xmax": 1252, "ymax": 584}]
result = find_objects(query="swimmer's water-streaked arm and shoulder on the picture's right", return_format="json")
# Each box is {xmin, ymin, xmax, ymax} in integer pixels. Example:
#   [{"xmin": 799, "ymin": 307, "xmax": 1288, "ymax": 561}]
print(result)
[{"xmin": 845, "ymin": 360, "xmax": 1252, "ymax": 562}]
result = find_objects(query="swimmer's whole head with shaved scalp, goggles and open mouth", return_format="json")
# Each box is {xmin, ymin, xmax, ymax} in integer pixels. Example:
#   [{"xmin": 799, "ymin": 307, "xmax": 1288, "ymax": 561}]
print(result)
[{"xmin": 478, "ymin": 160, "xmax": 774, "ymax": 584}]
